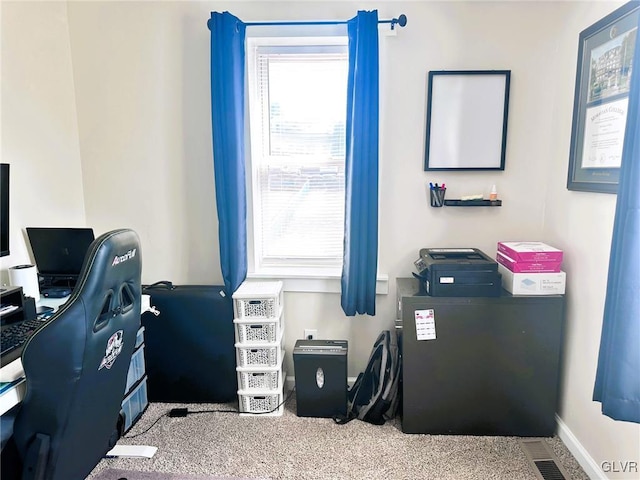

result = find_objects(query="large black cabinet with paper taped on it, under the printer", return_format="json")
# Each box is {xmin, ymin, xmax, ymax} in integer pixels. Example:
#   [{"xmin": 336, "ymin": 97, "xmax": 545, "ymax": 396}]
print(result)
[{"xmin": 397, "ymin": 278, "xmax": 564, "ymax": 436}]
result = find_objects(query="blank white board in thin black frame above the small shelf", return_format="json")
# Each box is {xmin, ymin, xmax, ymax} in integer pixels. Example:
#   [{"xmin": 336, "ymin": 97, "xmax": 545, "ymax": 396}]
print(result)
[{"xmin": 424, "ymin": 70, "xmax": 511, "ymax": 170}]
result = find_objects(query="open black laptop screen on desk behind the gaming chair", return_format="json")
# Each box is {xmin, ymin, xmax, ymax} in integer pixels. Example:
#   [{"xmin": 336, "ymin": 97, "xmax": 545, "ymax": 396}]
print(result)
[{"xmin": 27, "ymin": 227, "xmax": 95, "ymax": 287}]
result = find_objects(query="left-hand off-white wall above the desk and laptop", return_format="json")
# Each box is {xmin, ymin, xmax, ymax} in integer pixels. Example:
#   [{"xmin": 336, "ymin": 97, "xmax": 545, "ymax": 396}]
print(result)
[{"xmin": 0, "ymin": 1, "xmax": 85, "ymax": 283}]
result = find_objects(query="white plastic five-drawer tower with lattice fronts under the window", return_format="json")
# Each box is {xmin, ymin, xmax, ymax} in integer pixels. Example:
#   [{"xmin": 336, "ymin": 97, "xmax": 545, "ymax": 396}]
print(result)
[{"xmin": 233, "ymin": 281, "xmax": 285, "ymax": 416}]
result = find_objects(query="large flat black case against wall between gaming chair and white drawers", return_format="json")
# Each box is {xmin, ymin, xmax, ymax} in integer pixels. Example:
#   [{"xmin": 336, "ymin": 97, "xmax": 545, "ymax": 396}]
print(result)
[{"xmin": 142, "ymin": 281, "xmax": 238, "ymax": 403}]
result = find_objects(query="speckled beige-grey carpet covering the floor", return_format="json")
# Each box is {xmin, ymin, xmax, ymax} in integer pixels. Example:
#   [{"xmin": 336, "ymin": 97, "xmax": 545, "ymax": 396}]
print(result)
[{"xmin": 88, "ymin": 398, "xmax": 588, "ymax": 480}]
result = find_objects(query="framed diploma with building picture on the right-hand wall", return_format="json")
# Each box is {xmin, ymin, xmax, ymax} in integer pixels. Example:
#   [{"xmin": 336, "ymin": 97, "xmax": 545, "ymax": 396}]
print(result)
[{"xmin": 567, "ymin": 1, "xmax": 640, "ymax": 193}]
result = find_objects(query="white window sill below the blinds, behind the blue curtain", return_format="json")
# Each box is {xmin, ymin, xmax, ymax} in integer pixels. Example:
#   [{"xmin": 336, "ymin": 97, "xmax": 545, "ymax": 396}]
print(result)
[{"xmin": 247, "ymin": 271, "xmax": 389, "ymax": 295}]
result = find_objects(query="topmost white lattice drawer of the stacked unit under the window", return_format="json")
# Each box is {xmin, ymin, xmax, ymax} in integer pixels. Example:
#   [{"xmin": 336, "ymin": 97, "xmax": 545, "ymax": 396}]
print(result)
[{"xmin": 233, "ymin": 281, "xmax": 283, "ymax": 320}]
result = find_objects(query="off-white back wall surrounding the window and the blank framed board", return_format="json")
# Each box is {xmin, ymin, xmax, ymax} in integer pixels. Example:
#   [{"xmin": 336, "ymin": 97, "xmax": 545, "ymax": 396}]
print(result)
[{"xmin": 63, "ymin": 2, "xmax": 574, "ymax": 374}]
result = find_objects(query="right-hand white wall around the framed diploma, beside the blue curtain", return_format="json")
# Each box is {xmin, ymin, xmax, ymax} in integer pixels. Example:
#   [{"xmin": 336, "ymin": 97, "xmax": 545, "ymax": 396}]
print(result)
[{"xmin": 542, "ymin": 2, "xmax": 640, "ymax": 479}]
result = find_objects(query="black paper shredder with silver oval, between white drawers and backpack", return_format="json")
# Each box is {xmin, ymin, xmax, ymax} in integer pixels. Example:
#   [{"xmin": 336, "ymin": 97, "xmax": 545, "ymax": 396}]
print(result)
[{"xmin": 293, "ymin": 340, "xmax": 348, "ymax": 418}]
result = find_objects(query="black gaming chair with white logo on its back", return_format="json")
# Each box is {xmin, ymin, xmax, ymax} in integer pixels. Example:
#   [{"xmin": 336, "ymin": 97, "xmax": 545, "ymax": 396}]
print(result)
[{"xmin": 3, "ymin": 229, "xmax": 142, "ymax": 480}]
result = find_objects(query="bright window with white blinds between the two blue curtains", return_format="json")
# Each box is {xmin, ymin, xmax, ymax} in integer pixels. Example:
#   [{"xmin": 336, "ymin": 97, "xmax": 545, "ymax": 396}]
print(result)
[{"xmin": 248, "ymin": 37, "xmax": 349, "ymax": 273}]
